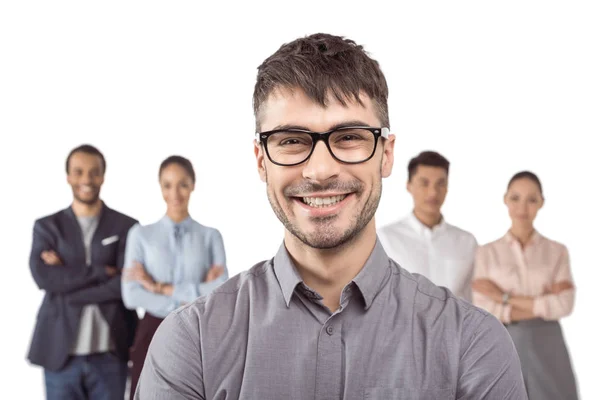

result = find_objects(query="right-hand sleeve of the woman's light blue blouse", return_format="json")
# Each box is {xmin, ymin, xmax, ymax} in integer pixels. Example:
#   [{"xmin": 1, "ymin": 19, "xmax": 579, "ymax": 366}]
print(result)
[{"xmin": 173, "ymin": 229, "xmax": 229, "ymax": 303}]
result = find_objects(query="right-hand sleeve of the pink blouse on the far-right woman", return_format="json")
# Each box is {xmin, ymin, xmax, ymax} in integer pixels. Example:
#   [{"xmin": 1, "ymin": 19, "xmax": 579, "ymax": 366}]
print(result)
[{"xmin": 533, "ymin": 246, "xmax": 575, "ymax": 320}]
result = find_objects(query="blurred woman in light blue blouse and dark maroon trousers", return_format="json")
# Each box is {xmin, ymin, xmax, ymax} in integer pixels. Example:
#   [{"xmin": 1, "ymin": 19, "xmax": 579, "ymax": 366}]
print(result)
[{"xmin": 121, "ymin": 156, "xmax": 228, "ymax": 399}]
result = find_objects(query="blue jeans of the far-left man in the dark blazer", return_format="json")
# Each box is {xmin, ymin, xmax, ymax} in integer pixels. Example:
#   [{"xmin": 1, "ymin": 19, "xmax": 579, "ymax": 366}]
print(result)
[{"xmin": 44, "ymin": 353, "xmax": 127, "ymax": 400}]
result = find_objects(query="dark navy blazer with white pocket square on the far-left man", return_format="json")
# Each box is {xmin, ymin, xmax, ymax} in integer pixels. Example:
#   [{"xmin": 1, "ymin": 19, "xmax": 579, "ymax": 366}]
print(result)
[{"xmin": 28, "ymin": 203, "xmax": 138, "ymax": 371}]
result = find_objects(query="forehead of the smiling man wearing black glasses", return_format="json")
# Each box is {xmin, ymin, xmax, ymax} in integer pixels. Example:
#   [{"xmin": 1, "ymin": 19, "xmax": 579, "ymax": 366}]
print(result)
[{"xmin": 259, "ymin": 89, "xmax": 381, "ymax": 132}]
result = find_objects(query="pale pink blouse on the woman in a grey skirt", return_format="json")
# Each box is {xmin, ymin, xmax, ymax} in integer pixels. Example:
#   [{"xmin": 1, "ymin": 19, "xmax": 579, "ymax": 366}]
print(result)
[{"xmin": 473, "ymin": 231, "xmax": 575, "ymax": 323}]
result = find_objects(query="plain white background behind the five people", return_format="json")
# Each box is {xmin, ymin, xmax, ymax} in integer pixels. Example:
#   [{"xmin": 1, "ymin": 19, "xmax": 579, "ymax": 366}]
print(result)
[{"xmin": 0, "ymin": 0, "xmax": 600, "ymax": 399}]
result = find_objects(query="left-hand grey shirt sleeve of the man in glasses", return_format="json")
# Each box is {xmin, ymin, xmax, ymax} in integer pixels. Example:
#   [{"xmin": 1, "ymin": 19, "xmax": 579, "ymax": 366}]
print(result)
[{"xmin": 134, "ymin": 312, "xmax": 205, "ymax": 400}]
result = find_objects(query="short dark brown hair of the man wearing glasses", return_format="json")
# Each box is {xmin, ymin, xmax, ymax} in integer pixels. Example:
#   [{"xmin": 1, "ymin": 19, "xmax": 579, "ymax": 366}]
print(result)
[{"xmin": 253, "ymin": 33, "xmax": 390, "ymax": 130}]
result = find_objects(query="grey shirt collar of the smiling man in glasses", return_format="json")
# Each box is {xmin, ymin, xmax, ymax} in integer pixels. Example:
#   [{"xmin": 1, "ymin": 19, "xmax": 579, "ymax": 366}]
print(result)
[{"xmin": 273, "ymin": 239, "xmax": 390, "ymax": 309}]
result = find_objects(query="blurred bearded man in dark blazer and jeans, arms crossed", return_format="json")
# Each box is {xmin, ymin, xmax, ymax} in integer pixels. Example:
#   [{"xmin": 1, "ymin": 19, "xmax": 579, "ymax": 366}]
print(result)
[{"xmin": 28, "ymin": 145, "xmax": 137, "ymax": 400}]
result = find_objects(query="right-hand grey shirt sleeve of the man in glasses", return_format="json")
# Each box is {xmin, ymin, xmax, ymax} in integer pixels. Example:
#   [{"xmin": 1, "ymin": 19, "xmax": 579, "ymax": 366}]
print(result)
[{"xmin": 456, "ymin": 315, "xmax": 527, "ymax": 400}]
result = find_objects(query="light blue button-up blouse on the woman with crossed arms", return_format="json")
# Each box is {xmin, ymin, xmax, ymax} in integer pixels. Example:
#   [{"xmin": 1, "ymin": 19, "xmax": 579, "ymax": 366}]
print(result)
[{"xmin": 121, "ymin": 216, "xmax": 229, "ymax": 318}]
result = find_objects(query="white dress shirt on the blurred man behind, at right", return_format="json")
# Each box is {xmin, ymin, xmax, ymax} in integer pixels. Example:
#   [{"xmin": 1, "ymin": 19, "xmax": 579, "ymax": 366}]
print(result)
[{"xmin": 377, "ymin": 212, "xmax": 477, "ymax": 301}]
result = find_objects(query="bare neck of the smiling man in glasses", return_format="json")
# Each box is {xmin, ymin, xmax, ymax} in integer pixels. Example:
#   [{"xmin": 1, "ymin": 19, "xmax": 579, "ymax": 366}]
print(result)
[{"xmin": 284, "ymin": 219, "xmax": 377, "ymax": 312}]
